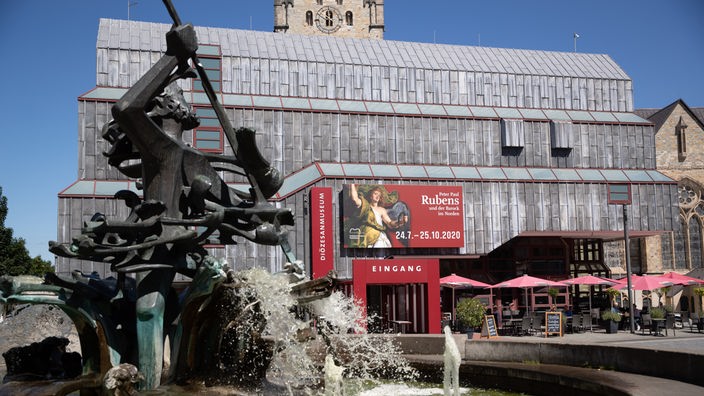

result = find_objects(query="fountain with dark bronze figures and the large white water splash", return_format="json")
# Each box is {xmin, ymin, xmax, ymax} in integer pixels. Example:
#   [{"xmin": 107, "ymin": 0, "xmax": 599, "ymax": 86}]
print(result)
[{"xmin": 0, "ymin": 0, "xmax": 413, "ymax": 394}]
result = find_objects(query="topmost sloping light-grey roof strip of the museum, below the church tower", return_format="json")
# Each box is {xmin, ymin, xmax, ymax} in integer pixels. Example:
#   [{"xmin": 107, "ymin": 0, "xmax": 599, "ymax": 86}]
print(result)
[{"xmin": 97, "ymin": 19, "xmax": 630, "ymax": 80}]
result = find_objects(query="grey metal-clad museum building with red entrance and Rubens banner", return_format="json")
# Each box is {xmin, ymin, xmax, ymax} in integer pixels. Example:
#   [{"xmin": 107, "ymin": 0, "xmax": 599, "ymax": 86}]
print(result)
[{"xmin": 56, "ymin": 1, "xmax": 680, "ymax": 333}]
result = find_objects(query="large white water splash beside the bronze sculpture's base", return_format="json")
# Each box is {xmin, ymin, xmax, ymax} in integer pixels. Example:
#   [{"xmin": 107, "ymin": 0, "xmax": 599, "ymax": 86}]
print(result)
[{"xmin": 238, "ymin": 269, "xmax": 417, "ymax": 389}]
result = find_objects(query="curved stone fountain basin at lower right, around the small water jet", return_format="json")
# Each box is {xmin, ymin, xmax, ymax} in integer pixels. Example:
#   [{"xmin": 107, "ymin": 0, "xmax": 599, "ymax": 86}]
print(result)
[{"xmin": 397, "ymin": 335, "xmax": 704, "ymax": 396}]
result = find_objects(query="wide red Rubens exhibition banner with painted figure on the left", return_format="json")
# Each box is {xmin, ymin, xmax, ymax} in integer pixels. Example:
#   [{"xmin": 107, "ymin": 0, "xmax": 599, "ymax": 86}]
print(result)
[{"xmin": 342, "ymin": 184, "xmax": 464, "ymax": 248}]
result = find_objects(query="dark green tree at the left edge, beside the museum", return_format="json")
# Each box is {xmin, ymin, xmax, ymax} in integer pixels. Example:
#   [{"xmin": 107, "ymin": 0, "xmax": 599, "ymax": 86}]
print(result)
[{"xmin": 0, "ymin": 187, "xmax": 54, "ymax": 277}]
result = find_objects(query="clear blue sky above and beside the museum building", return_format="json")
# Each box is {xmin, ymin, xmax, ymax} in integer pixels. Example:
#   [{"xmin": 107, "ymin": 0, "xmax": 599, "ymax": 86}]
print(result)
[{"xmin": 0, "ymin": 0, "xmax": 704, "ymax": 261}]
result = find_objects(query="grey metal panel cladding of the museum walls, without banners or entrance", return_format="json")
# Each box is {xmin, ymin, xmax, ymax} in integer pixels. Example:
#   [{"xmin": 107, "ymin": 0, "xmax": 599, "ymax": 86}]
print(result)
[{"xmin": 57, "ymin": 19, "xmax": 677, "ymax": 278}]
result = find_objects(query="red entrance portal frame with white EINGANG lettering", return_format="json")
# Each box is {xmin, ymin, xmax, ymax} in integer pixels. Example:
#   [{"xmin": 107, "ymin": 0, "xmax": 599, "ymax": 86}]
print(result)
[{"xmin": 352, "ymin": 259, "xmax": 440, "ymax": 334}]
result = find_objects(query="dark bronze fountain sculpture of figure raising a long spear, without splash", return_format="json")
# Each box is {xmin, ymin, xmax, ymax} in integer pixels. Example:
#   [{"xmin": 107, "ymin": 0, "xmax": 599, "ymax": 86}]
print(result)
[{"xmin": 0, "ymin": 0, "xmax": 332, "ymax": 389}]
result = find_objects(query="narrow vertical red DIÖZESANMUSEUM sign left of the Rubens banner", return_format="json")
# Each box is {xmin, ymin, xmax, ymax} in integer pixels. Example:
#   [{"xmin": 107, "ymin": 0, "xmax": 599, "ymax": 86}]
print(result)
[{"xmin": 310, "ymin": 187, "xmax": 335, "ymax": 279}]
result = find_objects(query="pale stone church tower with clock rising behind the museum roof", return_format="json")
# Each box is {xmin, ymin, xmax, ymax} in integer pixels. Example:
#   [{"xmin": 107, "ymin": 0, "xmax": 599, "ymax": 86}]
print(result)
[{"xmin": 274, "ymin": 0, "xmax": 384, "ymax": 39}]
